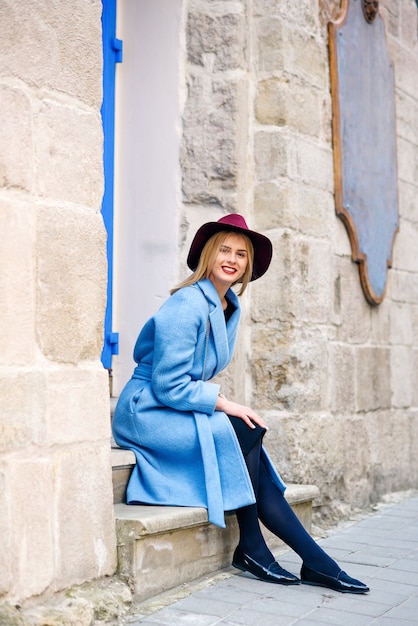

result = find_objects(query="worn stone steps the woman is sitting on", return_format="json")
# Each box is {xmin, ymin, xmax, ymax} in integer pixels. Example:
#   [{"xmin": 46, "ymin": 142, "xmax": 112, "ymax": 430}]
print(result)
[{"xmin": 112, "ymin": 444, "xmax": 319, "ymax": 602}]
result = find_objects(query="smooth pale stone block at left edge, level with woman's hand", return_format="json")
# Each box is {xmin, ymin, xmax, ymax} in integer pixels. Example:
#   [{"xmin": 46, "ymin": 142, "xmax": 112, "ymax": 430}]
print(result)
[{"xmin": 0, "ymin": 368, "xmax": 46, "ymax": 452}]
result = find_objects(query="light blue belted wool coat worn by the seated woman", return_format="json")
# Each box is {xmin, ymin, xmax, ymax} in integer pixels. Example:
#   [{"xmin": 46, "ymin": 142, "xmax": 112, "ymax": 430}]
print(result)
[{"xmin": 112, "ymin": 280, "xmax": 285, "ymax": 528}]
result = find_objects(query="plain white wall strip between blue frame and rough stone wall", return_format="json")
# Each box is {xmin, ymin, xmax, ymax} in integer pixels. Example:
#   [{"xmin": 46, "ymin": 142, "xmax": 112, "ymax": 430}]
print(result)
[{"xmin": 113, "ymin": 0, "xmax": 181, "ymax": 396}]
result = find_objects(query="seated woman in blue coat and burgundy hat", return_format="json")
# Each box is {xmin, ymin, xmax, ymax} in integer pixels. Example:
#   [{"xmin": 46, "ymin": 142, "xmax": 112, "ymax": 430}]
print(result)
[{"xmin": 113, "ymin": 214, "xmax": 369, "ymax": 593}]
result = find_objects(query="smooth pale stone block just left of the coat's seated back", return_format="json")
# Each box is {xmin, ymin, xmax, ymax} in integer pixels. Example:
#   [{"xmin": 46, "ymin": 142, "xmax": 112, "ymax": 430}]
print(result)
[{"xmin": 46, "ymin": 363, "xmax": 110, "ymax": 445}]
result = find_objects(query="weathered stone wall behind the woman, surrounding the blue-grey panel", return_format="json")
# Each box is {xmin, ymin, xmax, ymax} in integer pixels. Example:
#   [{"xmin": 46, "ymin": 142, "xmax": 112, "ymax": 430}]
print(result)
[{"xmin": 181, "ymin": 0, "xmax": 418, "ymax": 523}]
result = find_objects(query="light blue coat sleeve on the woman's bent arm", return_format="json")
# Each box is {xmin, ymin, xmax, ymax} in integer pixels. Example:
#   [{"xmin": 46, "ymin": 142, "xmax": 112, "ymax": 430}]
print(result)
[{"xmin": 152, "ymin": 288, "xmax": 220, "ymax": 414}]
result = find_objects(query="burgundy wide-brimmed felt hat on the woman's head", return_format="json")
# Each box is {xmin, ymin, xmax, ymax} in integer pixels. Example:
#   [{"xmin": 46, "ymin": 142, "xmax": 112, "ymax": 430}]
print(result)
[{"xmin": 187, "ymin": 213, "xmax": 273, "ymax": 280}]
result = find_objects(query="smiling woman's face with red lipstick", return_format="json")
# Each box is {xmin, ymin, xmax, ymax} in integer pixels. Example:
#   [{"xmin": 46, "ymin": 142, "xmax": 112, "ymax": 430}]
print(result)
[{"xmin": 209, "ymin": 234, "xmax": 248, "ymax": 291}]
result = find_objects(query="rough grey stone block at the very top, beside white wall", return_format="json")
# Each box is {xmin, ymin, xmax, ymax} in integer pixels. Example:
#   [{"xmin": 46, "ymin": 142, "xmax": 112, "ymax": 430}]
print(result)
[{"xmin": 187, "ymin": 13, "xmax": 246, "ymax": 72}]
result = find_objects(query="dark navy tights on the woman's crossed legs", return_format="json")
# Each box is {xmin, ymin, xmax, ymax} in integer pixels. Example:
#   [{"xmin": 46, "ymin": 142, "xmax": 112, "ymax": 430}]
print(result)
[{"xmin": 236, "ymin": 439, "xmax": 340, "ymax": 576}]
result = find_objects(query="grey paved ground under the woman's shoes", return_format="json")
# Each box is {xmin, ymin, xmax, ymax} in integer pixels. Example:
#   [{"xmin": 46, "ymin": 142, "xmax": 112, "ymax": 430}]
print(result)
[{"xmin": 123, "ymin": 492, "xmax": 418, "ymax": 626}]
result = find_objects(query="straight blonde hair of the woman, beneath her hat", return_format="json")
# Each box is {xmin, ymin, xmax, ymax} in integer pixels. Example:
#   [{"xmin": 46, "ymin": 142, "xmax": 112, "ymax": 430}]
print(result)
[{"xmin": 170, "ymin": 230, "xmax": 254, "ymax": 296}]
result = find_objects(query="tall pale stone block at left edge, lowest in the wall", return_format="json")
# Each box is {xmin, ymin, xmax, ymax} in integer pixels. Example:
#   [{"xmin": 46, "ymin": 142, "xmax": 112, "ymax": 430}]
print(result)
[{"xmin": 7, "ymin": 449, "xmax": 55, "ymax": 599}]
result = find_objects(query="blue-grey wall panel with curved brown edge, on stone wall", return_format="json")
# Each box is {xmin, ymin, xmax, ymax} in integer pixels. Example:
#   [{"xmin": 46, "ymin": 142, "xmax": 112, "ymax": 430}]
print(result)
[{"xmin": 328, "ymin": 0, "xmax": 399, "ymax": 305}]
